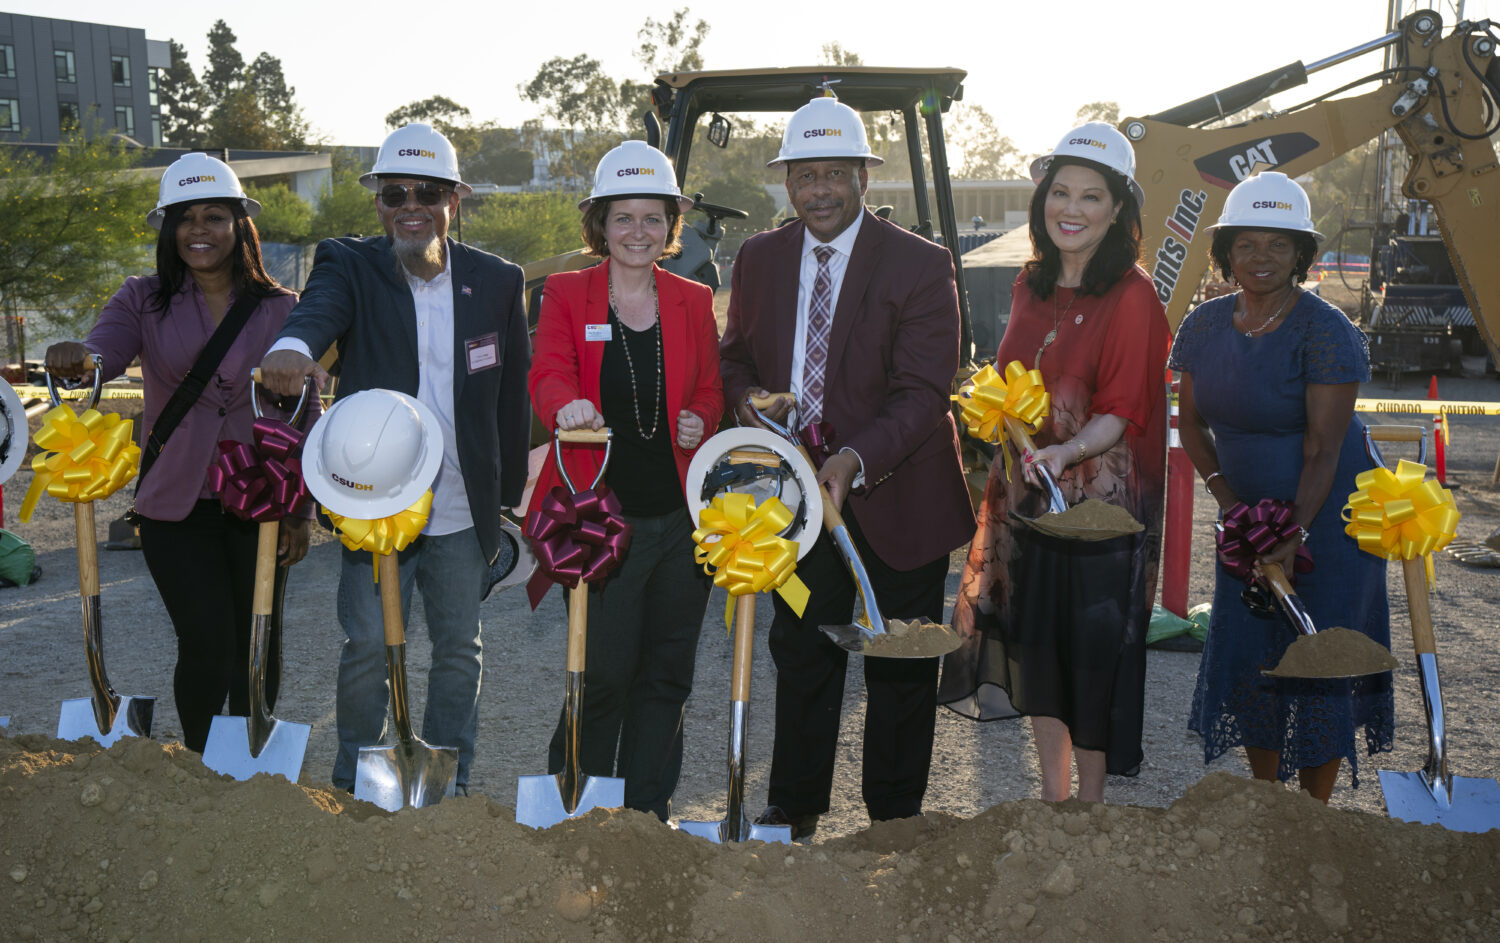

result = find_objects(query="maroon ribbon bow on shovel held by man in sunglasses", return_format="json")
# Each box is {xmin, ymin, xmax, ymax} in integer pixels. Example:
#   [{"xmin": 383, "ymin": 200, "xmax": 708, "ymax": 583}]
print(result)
[{"xmin": 209, "ymin": 418, "xmax": 312, "ymax": 523}]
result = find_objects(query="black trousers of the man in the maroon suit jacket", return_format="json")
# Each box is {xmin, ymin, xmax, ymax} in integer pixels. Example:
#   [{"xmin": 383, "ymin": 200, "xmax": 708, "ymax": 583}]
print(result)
[{"xmin": 768, "ymin": 505, "xmax": 948, "ymax": 822}]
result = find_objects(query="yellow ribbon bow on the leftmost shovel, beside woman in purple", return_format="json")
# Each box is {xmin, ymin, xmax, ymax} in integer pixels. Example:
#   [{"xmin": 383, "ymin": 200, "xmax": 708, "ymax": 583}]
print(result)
[{"xmin": 20, "ymin": 403, "xmax": 141, "ymax": 520}]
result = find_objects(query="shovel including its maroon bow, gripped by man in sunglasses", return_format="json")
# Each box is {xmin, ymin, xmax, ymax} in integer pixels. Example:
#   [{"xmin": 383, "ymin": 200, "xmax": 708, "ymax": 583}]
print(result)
[{"xmin": 203, "ymin": 367, "xmax": 315, "ymax": 783}]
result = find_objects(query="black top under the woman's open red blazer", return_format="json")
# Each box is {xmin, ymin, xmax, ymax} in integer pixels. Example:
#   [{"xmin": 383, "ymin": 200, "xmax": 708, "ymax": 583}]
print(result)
[{"xmin": 603, "ymin": 307, "xmax": 687, "ymax": 517}]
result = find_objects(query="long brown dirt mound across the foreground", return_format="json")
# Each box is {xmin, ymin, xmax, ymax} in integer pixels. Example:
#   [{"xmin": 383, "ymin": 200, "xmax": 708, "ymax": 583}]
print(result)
[{"xmin": 0, "ymin": 736, "xmax": 1500, "ymax": 943}]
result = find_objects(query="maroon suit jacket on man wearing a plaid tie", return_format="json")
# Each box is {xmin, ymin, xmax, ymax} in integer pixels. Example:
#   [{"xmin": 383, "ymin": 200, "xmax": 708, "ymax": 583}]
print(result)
[{"xmin": 719, "ymin": 210, "xmax": 975, "ymax": 570}]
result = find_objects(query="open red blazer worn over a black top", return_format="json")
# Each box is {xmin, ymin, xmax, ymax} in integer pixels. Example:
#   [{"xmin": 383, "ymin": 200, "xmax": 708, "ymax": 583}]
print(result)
[{"xmin": 527, "ymin": 259, "xmax": 725, "ymax": 513}]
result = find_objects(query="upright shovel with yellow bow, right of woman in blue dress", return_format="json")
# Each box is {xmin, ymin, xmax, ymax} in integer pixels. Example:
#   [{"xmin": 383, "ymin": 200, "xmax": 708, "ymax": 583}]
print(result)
[{"xmin": 1362, "ymin": 424, "xmax": 1500, "ymax": 832}]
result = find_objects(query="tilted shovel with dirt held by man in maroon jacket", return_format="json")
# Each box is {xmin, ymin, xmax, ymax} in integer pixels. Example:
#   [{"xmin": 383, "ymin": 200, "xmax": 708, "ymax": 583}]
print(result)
[{"xmin": 747, "ymin": 393, "xmax": 960, "ymax": 658}]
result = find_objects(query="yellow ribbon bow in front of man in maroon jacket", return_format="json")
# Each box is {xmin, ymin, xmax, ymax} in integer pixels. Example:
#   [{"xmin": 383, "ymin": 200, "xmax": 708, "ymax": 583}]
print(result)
[{"xmin": 693, "ymin": 493, "xmax": 807, "ymax": 625}]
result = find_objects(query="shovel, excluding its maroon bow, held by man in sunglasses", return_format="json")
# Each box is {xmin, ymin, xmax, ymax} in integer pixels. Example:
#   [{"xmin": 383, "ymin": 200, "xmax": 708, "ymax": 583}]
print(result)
[{"xmin": 203, "ymin": 367, "xmax": 312, "ymax": 783}]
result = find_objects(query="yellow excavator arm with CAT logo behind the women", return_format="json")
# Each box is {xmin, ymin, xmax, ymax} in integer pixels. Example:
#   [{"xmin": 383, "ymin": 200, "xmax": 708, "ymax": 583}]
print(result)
[{"xmin": 1121, "ymin": 10, "xmax": 1500, "ymax": 361}]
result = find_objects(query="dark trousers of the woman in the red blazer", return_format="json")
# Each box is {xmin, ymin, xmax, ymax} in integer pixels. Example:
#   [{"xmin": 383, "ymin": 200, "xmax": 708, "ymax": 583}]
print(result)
[{"xmin": 548, "ymin": 510, "xmax": 713, "ymax": 822}]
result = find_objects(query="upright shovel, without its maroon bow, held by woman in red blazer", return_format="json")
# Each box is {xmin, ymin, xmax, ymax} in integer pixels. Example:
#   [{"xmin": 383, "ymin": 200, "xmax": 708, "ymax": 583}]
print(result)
[{"xmin": 516, "ymin": 429, "xmax": 626, "ymax": 829}]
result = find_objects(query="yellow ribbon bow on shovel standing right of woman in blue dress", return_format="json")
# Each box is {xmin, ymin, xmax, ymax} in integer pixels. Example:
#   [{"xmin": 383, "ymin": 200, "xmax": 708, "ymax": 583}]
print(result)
[{"xmin": 1344, "ymin": 460, "xmax": 1460, "ymax": 585}]
